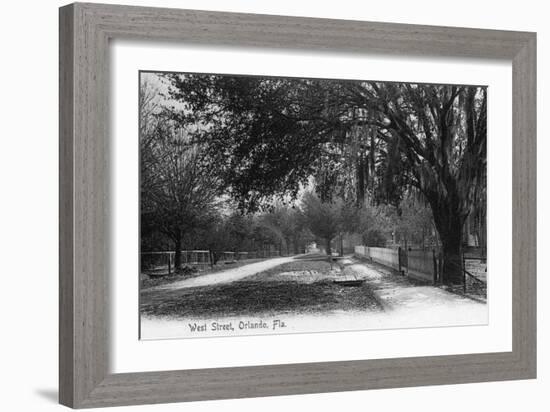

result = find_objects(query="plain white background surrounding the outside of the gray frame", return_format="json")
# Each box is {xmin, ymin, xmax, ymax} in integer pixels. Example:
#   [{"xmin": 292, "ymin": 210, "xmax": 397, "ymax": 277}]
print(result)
[{"xmin": 0, "ymin": 0, "xmax": 550, "ymax": 412}]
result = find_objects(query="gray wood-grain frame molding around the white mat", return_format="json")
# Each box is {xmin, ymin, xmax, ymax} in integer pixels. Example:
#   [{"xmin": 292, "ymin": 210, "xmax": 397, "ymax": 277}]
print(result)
[{"xmin": 59, "ymin": 3, "xmax": 536, "ymax": 408}]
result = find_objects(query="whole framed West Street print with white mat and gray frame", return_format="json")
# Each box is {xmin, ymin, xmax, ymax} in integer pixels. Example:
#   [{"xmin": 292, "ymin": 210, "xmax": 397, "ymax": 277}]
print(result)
[{"xmin": 60, "ymin": 3, "xmax": 536, "ymax": 408}]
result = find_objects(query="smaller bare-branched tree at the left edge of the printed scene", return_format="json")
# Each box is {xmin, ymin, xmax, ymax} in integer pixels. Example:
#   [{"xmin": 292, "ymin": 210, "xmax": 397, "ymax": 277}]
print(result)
[{"xmin": 141, "ymin": 114, "xmax": 219, "ymax": 269}]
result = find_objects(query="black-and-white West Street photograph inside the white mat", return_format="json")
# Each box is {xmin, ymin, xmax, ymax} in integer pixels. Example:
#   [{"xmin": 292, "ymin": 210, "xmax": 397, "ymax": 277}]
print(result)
[{"xmin": 139, "ymin": 71, "xmax": 488, "ymax": 339}]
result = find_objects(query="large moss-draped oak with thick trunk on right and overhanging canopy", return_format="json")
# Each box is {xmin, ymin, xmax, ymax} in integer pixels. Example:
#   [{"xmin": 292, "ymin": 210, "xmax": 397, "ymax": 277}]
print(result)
[{"xmin": 167, "ymin": 75, "xmax": 487, "ymax": 283}]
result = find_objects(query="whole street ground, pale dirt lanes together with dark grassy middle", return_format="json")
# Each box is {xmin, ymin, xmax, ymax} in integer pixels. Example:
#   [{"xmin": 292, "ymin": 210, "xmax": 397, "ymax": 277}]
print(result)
[{"xmin": 141, "ymin": 258, "xmax": 488, "ymax": 339}]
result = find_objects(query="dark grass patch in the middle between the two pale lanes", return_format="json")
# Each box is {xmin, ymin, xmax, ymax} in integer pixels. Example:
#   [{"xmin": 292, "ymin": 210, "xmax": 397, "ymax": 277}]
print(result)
[{"xmin": 141, "ymin": 260, "xmax": 382, "ymax": 319}]
